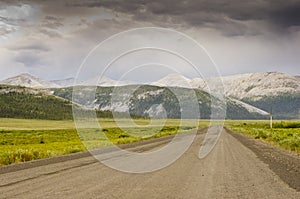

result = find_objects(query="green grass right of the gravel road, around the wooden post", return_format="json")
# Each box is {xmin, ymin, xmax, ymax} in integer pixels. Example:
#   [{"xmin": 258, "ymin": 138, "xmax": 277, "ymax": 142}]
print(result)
[{"xmin": 226, "ymin": 121, "xmax": 300, "ymax": 154}]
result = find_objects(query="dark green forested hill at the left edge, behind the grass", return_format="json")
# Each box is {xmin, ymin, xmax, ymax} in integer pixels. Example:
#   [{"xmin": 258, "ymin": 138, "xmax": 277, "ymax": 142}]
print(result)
[{"xmin": 0, "ymin": 85, "xmax": 73, "ymax": 120}]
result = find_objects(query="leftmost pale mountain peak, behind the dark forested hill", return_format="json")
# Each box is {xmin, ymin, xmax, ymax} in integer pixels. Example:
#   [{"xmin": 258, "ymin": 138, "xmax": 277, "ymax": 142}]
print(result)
[{"xmin": 0, "ymin": 73, "xmax": 58, "ymax": 88}]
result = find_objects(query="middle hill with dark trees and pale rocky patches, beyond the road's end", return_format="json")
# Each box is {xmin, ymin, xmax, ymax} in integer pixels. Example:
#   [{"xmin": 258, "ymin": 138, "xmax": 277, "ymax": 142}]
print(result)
[{"xmin": 53, "ymin": 85, "xmax": 267, "ymax": 119}]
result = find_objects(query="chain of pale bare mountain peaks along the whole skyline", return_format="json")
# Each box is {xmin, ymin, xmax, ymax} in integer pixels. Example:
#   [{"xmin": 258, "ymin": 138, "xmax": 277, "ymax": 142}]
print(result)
[{"xmin": 0, "ymin": 72, "xmax": 300, "ymax": 100}]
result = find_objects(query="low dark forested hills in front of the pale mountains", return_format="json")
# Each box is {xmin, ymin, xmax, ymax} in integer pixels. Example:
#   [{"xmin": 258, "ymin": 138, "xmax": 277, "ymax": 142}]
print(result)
[{"xmin": 0, "ymin": 85, "xmax": 265, "ymax": 120}]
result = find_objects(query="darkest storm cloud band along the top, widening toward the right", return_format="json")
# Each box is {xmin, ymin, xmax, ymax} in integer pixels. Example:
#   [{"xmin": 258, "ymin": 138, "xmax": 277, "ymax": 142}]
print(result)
[{"xmin": 67, "ymin": 0, "xmax": 300, "ymax": 35}]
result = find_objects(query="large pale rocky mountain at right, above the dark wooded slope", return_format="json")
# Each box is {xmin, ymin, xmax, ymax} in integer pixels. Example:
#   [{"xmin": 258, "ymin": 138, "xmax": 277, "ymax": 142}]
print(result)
[{"xmin": 191, "ymin": 72, "xmax": 300, "ymax": 99}]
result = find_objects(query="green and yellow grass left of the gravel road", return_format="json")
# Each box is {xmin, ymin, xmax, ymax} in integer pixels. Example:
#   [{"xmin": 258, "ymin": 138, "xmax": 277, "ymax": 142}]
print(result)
[{"xmin": 0, "ymin": 118, "xmax": 208, "ymax": 165}]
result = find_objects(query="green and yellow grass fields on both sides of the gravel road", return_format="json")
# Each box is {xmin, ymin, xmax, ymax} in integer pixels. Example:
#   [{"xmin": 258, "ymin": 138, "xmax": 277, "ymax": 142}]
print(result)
[{"xmin": 0, "ymin": 118, "xmax": 300, "ymax": 165}]
